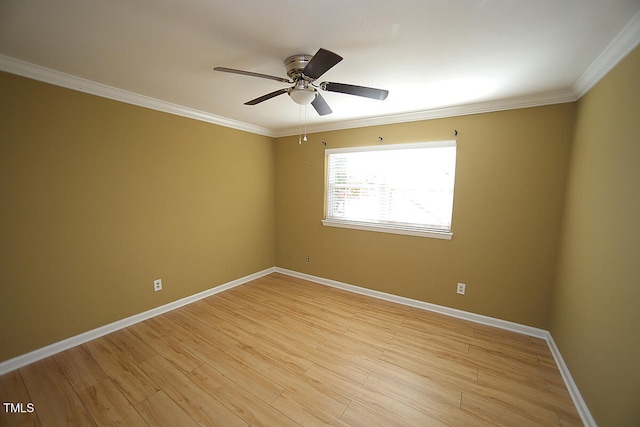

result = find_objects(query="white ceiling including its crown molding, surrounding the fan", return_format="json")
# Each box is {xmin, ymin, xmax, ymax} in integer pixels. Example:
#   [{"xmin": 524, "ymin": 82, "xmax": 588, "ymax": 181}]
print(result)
[{"xmin": 0, "ymin": 0, "xmax": 640, "ymax": 136}]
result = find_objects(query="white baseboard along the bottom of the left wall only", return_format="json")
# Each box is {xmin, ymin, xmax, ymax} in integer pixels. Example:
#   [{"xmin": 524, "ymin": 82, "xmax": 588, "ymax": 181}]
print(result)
[{"xmin": 0, "ymin": 267, "xmax": 276, "ymax": 375}]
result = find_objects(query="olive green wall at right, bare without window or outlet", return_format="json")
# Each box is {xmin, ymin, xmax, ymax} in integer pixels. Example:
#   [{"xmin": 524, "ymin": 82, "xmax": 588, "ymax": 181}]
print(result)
[{"xmin": 549, "ymin": 48, "xmax": 640, "ymax": 426}]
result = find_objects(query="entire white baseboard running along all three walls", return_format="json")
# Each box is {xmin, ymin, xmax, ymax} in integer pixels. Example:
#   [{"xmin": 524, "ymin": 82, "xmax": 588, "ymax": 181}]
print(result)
[{"xmin": 0, "ymin": 267, "xmax": 597, "ymax": 427}]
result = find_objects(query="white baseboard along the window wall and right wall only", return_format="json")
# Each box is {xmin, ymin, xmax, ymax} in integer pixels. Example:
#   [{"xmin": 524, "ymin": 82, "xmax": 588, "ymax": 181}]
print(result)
[{"xmin": 275, "ymin": 267, "xmax": 597, "ymax": 427}]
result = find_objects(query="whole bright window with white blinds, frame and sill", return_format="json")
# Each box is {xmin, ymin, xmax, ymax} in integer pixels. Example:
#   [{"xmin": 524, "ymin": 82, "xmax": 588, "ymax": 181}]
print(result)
[{"xmin": 322, "ymin": 141, "xmax": 456, "ymax": 239}]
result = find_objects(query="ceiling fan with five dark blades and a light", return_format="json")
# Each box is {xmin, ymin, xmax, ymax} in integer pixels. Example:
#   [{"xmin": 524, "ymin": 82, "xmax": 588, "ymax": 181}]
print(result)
[{"xmin": 214, "ymin": 48, "xmax": 389, "ymax": 116}]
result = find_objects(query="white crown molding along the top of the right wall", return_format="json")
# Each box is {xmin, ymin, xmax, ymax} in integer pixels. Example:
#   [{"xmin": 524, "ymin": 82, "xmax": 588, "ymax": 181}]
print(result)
[{"xmin": 572, "ymin": 12, "xmax": 640, "ymax": 98}]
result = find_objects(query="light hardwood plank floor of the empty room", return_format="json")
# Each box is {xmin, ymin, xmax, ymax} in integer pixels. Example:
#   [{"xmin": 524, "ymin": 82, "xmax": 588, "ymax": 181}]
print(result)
[{"xmin": 0, "ymin": 274, "xmax": 582, "ymax": 427}]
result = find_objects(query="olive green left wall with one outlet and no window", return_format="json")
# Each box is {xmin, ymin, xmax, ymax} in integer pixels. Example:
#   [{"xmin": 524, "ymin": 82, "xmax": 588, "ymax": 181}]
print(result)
[{"xmin": 0, "ymin": 73, "xmax": 275, "ymax": 361}]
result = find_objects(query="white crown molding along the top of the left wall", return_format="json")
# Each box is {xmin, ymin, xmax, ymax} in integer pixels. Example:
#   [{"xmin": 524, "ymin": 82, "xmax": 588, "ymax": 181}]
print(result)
[{"xmin": 0, "ymin": 54, "xmax": 274, "ymax": 137}]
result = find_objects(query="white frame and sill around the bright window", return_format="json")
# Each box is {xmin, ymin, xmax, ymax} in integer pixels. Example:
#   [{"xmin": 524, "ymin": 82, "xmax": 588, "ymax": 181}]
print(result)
[{"xmin": 322, "ymin": 140, "xmax": 457, "ymax": 240}]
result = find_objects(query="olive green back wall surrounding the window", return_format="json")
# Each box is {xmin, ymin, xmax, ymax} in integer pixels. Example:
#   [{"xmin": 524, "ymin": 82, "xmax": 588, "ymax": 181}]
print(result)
[{"xmin": 276, "ymin": 104, "xmax": 575, "ymax": 328}]
